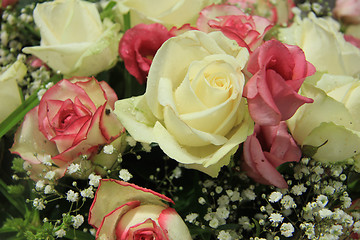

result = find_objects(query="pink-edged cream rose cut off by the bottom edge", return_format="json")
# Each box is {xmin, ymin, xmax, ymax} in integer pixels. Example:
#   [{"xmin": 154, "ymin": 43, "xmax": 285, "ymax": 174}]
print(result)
[{"xmin": 89, "ymin": 179, "xmax": 191, "ymax": 240}]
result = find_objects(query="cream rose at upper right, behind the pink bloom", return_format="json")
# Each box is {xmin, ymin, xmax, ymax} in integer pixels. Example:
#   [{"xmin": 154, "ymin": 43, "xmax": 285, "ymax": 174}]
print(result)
[{"xmin": 279, "ymin": 14, "xmax": 360, "ymax": 77}]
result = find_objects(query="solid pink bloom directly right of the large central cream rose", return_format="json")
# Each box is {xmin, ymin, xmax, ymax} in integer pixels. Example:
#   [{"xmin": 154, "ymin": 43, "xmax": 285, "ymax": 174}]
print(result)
[{"xmin": 243, "ymin": 40, "xmax": 315, "ymax": 125}]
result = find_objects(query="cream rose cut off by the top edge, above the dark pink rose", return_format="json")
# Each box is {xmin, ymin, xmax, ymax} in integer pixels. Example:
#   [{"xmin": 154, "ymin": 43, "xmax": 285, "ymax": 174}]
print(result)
[{"xmin": 117, "ymin": 0, "xmax": 214, "ymax": 27}]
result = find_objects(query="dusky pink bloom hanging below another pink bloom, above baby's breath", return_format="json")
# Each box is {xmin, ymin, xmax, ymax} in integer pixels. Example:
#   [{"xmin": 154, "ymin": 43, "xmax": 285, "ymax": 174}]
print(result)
[{"xmin": 242, "ymin": 122, "xmax": 301, "ymax": 188}]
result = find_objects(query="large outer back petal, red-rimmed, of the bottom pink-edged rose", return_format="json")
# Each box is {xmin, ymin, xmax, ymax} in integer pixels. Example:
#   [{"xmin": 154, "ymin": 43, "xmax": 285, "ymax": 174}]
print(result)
[{"xmin": 89, "ymin": 179, "xmax": 174, "ymax": 229}]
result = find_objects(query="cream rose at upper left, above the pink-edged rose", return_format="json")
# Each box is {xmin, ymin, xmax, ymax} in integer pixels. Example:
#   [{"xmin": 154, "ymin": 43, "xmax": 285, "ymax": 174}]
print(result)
[{"xmin": 23, "ymin": 0, "xmax": 120, "ymax": 77}]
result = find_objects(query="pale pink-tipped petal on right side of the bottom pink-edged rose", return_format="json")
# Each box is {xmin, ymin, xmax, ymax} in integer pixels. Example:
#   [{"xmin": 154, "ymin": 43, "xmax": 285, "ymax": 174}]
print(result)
[{"xmin": 158, "ymin": 208, "xmax": 192, "ymax": 240}]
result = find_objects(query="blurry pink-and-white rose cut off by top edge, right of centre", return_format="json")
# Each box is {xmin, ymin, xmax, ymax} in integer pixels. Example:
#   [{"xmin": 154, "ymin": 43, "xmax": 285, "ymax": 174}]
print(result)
[{"xmin": 226, "ymin": 0, "xmax": 295, "ymax": 25}]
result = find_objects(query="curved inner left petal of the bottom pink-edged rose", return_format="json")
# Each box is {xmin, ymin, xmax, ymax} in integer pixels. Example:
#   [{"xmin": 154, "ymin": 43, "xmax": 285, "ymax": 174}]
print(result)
[{"xmin": 95, "ymin": 201, "xmax": 140, "ymax": 240}]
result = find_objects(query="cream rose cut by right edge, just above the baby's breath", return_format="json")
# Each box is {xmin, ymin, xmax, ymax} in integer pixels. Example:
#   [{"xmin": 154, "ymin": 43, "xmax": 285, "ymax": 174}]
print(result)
[{"xmin": 287, "ymin": 73, "xmax": 360, "ymax": 163}]
